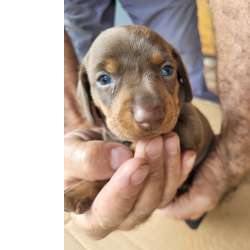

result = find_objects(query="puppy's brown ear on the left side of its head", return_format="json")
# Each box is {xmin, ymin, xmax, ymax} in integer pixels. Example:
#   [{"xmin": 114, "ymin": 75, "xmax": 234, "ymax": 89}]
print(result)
[{"xmin": 77, "ymin": 64, "xmax": 95, "ymax": 125}]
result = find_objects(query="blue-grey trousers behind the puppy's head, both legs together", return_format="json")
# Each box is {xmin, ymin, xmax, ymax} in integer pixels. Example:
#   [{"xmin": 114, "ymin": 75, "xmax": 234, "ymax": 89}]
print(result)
[{"xmin": 64, "ymin": 0, "xmax": 218, "ymax": 101}]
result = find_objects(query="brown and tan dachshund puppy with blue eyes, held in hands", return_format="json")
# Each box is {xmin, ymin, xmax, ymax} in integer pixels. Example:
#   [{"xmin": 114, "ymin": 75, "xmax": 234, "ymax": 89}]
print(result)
[{"xmin": 65, "ymin": 25, "xmax": 213, "ymax": 229}]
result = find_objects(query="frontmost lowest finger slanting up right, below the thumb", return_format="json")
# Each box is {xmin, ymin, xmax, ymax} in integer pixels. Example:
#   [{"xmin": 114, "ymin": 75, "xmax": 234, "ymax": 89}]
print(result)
[{"xmin": 75, "ymin": 159, "xmax": 149, "ymax": 239}]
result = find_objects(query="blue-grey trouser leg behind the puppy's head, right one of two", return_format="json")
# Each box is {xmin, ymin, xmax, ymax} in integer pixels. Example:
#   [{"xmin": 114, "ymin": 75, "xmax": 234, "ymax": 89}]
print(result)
[{"xmin": 120, "ymin": 0, "xmax": 218, "ymax": 101}]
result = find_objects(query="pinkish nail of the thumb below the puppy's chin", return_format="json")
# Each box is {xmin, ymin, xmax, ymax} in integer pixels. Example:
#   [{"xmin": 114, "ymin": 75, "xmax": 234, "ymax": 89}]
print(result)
[{"xmin": 111, "ymin": 147, "xmax": 132, "ymax": 170}]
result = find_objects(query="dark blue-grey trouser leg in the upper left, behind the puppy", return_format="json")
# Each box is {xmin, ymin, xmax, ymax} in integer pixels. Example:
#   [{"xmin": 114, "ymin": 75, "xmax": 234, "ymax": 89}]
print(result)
[{"xmin": 64, "ymin": 0, "xmax": 115, "ymax": 61}]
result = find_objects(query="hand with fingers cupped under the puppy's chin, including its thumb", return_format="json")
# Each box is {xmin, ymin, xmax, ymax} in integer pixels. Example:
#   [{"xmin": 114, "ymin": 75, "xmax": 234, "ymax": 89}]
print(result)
[{"xmin": 65, "ymin": 130, "xmax": 195, "ymax": 238}]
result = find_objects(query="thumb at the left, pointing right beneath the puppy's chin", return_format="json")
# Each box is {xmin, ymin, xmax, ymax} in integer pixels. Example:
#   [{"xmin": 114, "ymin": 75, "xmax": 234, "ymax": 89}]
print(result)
[{"xmin": 64, "ymin": 134, "xmax": 133, "ymax": 182}]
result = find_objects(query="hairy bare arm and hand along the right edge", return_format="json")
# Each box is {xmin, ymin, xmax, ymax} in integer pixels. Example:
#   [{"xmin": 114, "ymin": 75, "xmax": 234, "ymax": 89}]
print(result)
[{"xmin": 162, "ymin": 0, "xmax": 250, "ymax": 219}]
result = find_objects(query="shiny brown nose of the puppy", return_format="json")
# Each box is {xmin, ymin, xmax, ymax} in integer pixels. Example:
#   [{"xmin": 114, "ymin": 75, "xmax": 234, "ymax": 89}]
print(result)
[{"xmin": 133, "ymin": 103, "xmax": 165, "ymax": 130}]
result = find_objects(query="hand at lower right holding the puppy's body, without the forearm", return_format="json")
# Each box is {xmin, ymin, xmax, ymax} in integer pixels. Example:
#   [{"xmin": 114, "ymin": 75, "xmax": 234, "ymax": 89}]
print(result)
[{"xmin": 162, "ymin": 138, "xmax": 249, "ymax": 220}]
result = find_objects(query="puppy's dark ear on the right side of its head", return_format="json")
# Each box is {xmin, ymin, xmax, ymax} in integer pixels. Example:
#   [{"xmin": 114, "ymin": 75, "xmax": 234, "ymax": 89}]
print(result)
[{"xmin": 173, "ymin": 49, "xmax": 193, "ymax": 102}]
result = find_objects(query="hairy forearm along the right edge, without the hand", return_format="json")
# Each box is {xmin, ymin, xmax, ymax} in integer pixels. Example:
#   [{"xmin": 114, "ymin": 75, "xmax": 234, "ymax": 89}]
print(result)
[{"xmin": 211, "ymin": 0, "xmax": 250, "ymax": 183}]
